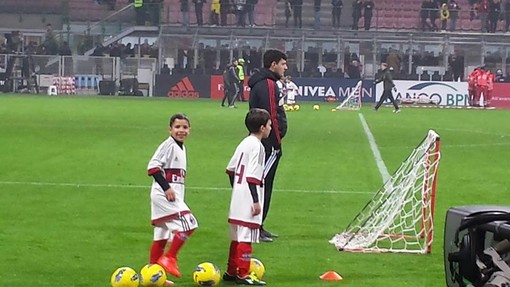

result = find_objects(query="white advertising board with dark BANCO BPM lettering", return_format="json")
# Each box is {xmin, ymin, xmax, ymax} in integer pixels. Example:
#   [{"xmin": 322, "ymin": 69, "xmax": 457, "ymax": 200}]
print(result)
[{"xmin": 375, "ymin": 81, "xmax": 468, "ymax": 106}]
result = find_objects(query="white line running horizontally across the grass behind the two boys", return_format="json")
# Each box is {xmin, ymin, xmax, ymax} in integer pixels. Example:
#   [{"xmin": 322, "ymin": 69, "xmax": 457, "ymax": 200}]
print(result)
[{"xmin": 0, "ymin": 181, "xmax": 373, "ymax": 194}]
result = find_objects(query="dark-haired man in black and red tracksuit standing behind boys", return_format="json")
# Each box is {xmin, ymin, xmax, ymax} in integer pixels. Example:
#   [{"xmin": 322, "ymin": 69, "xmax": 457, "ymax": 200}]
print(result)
[{"xmin": 248, "ymin": 50, "xmax": 287, "ymax": 242}]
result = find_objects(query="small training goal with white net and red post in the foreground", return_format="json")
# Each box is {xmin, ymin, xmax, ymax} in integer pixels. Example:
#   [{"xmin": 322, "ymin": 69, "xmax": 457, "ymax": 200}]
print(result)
[{"xmin": 330, "ymin": 130, "xmax": 441, "ymax": 253}]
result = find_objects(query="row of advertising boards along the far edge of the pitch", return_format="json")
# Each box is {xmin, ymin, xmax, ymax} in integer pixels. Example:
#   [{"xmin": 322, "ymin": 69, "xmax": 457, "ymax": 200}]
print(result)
[{"xmin": 154, "ymin": 74, "xmax": 510, "ymax": 109}]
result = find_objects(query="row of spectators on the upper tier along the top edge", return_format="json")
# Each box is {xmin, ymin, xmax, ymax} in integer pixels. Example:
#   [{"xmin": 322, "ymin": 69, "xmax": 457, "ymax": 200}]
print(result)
[{"xmin": 146, "ymin": 0, "xmax": 510, "ymax": 33}]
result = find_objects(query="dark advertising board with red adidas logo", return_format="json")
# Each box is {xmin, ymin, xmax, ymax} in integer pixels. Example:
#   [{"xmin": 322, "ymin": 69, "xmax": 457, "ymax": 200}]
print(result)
[{"xmin": 154, "ymin": 74, "xmax": 211, "ymax": 99}]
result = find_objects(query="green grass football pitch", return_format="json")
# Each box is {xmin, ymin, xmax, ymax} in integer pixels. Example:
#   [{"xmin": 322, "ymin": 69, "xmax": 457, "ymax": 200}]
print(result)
[{"xmin": 0, "ymin": 95, "xmax": 510, "ymax": 287}]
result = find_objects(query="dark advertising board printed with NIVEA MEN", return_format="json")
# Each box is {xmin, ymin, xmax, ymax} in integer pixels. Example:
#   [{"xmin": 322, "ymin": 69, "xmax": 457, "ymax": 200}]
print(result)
[{"xmin": 292, "ymin": 78, "xmax": 375, "ymax": 103}]
